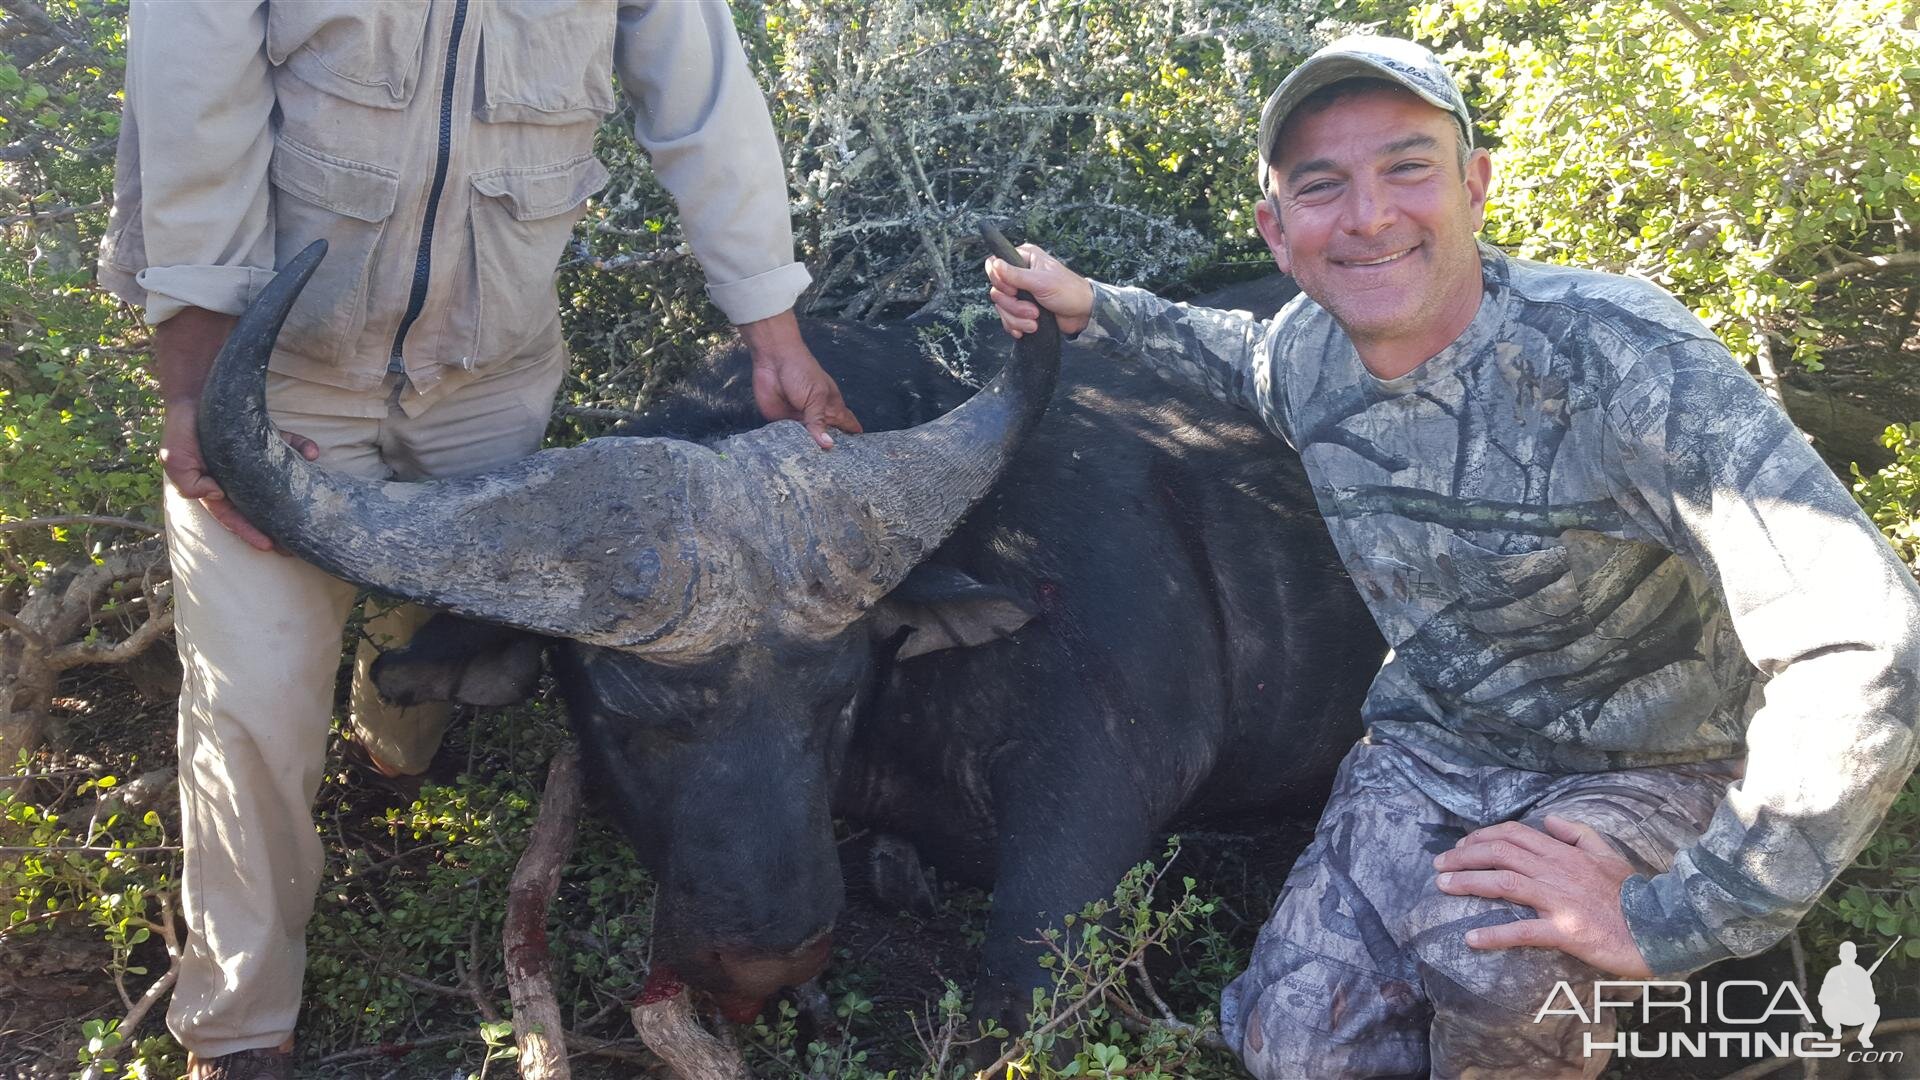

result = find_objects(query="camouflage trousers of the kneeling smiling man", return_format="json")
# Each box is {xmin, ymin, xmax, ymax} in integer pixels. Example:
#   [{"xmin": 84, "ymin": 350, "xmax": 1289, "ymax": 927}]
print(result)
[{"xmin": 1221, "ymin": 740, "xmax": 1740, "ymax": 1080}]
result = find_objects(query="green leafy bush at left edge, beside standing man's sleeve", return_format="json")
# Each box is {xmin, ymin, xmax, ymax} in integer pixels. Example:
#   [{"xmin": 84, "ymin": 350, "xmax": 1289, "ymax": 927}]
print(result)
[{"xmin": 0, "ymin": 0, "xmax": 159, "ymax": 580}]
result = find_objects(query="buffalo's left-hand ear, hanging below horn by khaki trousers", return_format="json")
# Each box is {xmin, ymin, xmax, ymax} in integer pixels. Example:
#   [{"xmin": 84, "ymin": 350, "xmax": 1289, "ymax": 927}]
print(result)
[{"xmin": 372, "ymin": 615, "xmax": 547, "ymax": 707}]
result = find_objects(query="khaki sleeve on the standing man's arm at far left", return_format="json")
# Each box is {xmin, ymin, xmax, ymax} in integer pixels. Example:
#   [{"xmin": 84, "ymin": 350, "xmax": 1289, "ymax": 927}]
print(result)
[{"xmin": 100, "ymin": 0, "xmax": 275, "ymax": 323}]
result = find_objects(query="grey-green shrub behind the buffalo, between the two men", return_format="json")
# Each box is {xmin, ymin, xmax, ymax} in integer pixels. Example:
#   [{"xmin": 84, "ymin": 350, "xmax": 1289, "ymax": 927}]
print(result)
[{"xmin": 563, "ymin": 0, "xmax": 1321, "ymax": 407}]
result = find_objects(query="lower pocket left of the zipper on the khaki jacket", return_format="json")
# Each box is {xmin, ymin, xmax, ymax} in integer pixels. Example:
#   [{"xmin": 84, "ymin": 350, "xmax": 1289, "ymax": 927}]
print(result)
[{"xmin": 267, "ymin": 135, "xmax": 399, "ymax": 365}]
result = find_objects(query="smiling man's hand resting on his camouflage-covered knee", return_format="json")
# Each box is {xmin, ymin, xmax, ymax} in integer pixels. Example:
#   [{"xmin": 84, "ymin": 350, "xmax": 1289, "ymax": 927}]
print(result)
[{"xmin": 1434, "ymin": 815, "xmax": 1653, "ymax": 978}]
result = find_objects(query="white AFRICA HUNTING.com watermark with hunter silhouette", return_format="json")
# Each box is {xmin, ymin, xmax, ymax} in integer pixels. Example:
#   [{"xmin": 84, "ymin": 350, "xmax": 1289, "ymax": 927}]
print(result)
[{"xmin": 1534, "ymin": 940, "xmax": 1903, "ymax": 1063}]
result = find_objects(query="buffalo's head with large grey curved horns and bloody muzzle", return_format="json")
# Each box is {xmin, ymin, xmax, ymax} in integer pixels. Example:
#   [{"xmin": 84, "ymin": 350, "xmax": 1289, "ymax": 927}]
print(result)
[{"xmin": 202, "ymin": 233, "xmax": 1060, "ymax": 1013}]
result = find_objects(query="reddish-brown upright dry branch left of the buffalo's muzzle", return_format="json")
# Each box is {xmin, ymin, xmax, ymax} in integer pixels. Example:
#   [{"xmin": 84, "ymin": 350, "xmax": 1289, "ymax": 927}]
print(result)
[{"xmin": 501, "ymin": 746, "xmax": 580, "ymax": 1080}]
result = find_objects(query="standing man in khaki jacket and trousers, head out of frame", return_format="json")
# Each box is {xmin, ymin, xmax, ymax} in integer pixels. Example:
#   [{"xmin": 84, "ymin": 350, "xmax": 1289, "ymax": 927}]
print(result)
[{"xmin": 100, "ymin": 0, "xmax": 860, "ymax": 1080}]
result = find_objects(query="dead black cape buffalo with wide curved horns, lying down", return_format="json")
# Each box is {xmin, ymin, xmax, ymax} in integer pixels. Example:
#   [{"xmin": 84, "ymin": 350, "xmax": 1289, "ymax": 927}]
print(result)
[{"xmin": 202, "ymin": 237, "xmax": 1382, "ymax": 1019}]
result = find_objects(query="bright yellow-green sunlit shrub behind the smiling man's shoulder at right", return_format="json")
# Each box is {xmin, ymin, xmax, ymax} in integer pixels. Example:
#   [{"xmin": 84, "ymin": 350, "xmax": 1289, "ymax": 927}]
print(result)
[{"xmin": 1409, "ymin": 0, "xmax": 1920, "ymax": 377}]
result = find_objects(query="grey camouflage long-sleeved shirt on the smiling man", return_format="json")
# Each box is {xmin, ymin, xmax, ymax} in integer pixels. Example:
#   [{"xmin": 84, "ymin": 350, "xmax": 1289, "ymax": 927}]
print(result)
[{"xmin": 1081, "ymin": 246, "xmax": 1920, "ymax": 974}]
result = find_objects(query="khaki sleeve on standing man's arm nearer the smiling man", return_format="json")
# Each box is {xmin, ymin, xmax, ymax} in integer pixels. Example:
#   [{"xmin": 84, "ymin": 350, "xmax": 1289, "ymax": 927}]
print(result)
[{"xmin": 614, "ymin": 0, "xmax": 812, "ymax": 323}]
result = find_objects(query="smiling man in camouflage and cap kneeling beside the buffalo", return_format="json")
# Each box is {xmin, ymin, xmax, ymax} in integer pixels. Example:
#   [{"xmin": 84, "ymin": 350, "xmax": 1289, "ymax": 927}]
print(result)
[{"xmin": 987, "ymin": 38, "xmax": 1920, "ymax": 1080}]
